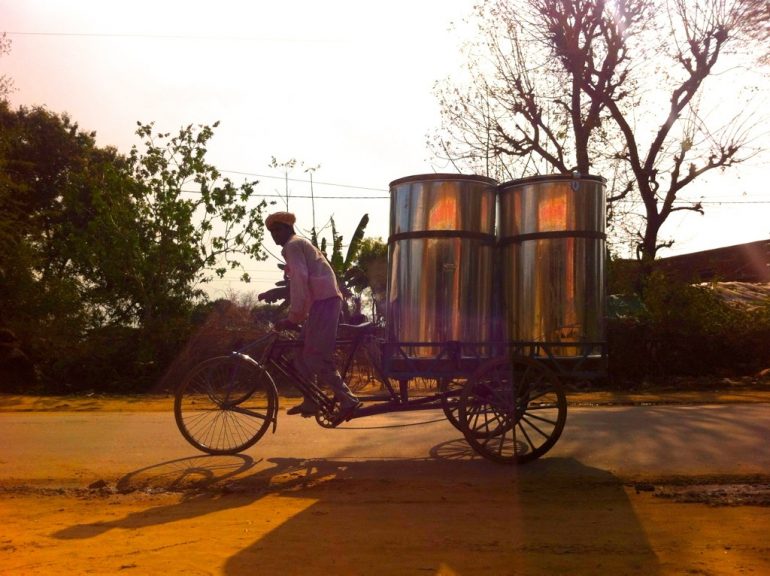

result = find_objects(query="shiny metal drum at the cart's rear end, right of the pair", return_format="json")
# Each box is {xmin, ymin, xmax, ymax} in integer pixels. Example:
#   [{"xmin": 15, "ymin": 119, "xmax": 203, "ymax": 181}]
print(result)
[{"xmin": 498, "ymin": 175, "xmax": 605, "ymax": 356}]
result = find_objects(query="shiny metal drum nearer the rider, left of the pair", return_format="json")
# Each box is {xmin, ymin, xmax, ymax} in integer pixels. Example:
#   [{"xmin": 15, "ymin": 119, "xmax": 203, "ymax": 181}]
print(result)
[{"xmin": 387, "ymin": 174, "xmax": 497, "ymax": 358}]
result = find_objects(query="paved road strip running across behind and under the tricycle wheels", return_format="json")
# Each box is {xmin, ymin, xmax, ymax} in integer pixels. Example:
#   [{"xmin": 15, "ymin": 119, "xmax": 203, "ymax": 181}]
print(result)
[{"xmin": 0, "ymin": 404, "xmax": 770, "ymax": 486}]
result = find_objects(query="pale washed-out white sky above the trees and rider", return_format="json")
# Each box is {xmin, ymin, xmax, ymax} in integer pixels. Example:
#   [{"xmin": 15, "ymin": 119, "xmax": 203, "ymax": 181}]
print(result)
[{"xmin": 0, "ymin": 0, "xmax": 770, "ymax": 296}]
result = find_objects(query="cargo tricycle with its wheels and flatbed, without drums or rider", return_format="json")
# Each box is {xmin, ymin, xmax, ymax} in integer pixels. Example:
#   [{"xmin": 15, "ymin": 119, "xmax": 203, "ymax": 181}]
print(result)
[{"xmin": 174, "ymin": 323, "xmax": 606, "ymax": 464}]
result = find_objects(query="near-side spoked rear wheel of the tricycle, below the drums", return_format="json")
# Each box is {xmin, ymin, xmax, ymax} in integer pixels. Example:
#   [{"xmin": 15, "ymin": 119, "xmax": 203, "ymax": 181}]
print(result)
[{"xmin": 458, "ymin": 356, "xmax": 567, "ymax": 464}]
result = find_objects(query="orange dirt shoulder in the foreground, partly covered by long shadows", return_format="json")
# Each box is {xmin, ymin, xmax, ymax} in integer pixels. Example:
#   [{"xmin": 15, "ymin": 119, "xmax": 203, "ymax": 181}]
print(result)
[{"xmin": 0, "ymin": 444, "xmax": 770, "ymax": 576}]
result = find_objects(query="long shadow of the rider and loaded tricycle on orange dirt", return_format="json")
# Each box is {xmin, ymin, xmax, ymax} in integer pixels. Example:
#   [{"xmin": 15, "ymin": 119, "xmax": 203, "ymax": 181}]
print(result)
[{"xmin": 54, "ymin": 439, "xmax": 660, "ymax": 576}]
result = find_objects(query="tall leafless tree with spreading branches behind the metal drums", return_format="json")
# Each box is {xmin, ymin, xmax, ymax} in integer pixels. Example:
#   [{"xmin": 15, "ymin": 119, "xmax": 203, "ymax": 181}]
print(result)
[{"xmin": 432, "ymin": 0, "xmax": 768, "ymax": 262}]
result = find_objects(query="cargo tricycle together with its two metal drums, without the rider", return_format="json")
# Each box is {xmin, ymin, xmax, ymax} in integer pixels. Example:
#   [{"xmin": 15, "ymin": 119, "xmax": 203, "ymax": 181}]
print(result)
[{"xmin": 174, "ymin": 174, "xmax": 606, "ymax": 464}]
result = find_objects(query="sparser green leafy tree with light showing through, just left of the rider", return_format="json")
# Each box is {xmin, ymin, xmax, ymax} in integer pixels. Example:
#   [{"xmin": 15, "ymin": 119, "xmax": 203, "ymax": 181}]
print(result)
[{"xmin": 73, "ymin": 124, "xmax": 265, "ymax": 378}]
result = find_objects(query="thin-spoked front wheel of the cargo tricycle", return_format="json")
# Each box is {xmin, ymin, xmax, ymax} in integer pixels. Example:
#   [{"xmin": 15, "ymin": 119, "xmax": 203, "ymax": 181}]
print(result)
[{"xmin": 174, "ymin": 356, "xmax": 278, "ymax": 454}]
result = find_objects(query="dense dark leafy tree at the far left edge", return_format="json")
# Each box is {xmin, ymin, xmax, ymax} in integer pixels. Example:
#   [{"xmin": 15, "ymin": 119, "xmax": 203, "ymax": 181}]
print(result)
[{"xmin": 0, "ymin": 102, "xmax": 141, "ymax": 392}]
